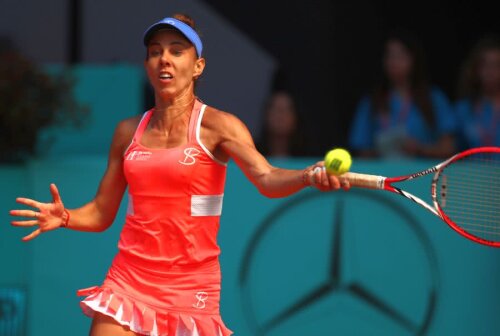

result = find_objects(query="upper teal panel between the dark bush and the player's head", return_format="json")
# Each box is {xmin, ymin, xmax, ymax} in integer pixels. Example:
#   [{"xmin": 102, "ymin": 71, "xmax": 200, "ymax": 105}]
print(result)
[{"xmin": 39, "ymin": 63, "xmax": 144, "ymax": 158}]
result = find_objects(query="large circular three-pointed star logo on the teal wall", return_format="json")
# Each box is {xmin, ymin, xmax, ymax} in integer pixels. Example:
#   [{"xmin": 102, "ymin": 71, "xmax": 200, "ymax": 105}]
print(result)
[{"xmin": 239, "ymin": 190, "xmax": 438, "ymax": 336}]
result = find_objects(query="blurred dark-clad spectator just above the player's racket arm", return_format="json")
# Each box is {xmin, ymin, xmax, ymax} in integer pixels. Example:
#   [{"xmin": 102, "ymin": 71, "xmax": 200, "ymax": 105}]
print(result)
[{"xmin": 257, "ymin": 90, "xmax": 305, "ymax": 157}]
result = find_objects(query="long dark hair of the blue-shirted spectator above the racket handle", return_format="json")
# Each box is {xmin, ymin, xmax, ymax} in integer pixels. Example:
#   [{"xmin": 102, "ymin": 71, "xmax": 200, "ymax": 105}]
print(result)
[{"xmin": 371, "ymin": 32, "xmax": 434, "ymax": 125}]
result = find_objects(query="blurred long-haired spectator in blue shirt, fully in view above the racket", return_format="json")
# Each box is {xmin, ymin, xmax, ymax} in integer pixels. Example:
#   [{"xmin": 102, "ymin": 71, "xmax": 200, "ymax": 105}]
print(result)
[{"xmin": 349, "ymin": 34, "xmax": 457, "ymax": 157}]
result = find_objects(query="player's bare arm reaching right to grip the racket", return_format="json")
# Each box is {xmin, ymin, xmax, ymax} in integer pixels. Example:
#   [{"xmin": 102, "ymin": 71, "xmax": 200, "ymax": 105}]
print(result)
[{"xmin": 203, "ymin": 111, "xmax": 349, "ymax": 197}]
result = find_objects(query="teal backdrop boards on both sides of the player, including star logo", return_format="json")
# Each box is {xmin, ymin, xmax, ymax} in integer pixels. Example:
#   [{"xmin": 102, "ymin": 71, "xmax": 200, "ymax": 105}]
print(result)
[{"xmin": 0, "ymin": 64, "xmax": 500, "ymax": 336}]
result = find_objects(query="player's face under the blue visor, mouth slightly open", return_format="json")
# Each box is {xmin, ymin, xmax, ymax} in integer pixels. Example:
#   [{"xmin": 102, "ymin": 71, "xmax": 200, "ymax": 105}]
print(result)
[{"xmin": 144, "ymin": 29, "xmax": 205, "ymax": 98}]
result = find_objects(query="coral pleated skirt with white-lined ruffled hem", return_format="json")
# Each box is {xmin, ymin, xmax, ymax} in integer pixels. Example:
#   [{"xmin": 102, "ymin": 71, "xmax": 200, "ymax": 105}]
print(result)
[{"xmin": 77, "ymin": 252, "xmax": 232, "ymax": 336}]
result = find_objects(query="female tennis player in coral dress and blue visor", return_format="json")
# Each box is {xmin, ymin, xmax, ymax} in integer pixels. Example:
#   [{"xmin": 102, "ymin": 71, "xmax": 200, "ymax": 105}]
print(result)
[{"xmin": 11, "ymin": 15, "xmax": 349, "ymax": 336}]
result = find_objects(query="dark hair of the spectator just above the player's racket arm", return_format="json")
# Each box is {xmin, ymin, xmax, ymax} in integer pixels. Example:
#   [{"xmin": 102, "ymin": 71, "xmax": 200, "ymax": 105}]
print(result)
[{"xmin": 257, "ymin": 90, "xmax": 306, "ymax": 156}]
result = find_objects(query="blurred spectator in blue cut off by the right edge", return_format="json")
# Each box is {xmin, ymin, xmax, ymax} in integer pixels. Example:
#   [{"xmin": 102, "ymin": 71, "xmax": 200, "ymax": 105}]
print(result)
[{"xmin": 456, "ymin": 36, "xmax": 500, "ymax": 148}]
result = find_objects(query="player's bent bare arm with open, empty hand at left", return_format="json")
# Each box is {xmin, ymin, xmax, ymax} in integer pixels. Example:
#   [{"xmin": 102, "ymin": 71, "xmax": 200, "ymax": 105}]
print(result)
[{"xmin": 10, "ymin": 118, "xmax": 138, "ymax": 241}]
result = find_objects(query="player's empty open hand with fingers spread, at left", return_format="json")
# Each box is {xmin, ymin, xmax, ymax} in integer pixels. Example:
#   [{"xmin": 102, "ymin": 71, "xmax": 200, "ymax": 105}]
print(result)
[{"xmin": 10, "ymin": 184, "xmax": 64, "ymax": 241}]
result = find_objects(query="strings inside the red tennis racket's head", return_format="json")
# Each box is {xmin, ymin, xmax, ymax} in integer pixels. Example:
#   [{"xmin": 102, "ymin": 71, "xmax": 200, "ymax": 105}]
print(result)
[{"xmin": 437, "ymin": 150, "xmax": 500, "ymax": 242}]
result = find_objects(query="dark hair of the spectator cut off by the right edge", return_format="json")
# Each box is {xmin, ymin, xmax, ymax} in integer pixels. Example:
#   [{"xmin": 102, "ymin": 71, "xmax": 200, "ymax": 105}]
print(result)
[{"xmin": 458, "ymin": 35, "xmax": 500, "ymax": 101}]
